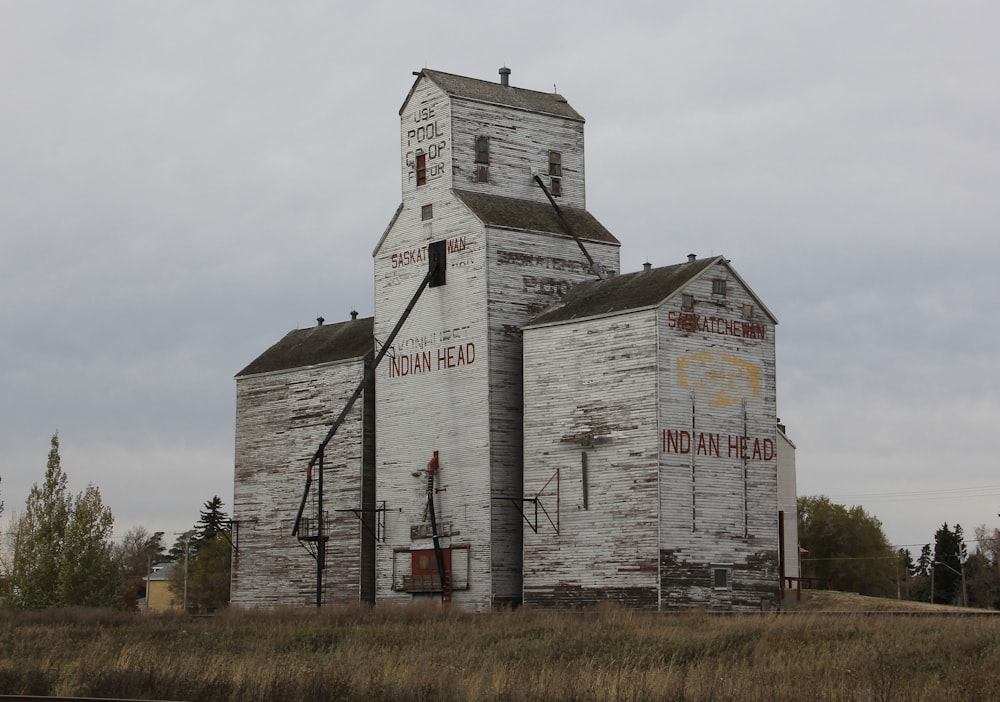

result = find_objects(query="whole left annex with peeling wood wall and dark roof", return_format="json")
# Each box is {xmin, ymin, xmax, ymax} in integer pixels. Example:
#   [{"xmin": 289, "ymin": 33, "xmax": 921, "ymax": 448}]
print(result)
[{"xmin": 230, "ymin": 317, "xmax": 377, "ymax": 607}]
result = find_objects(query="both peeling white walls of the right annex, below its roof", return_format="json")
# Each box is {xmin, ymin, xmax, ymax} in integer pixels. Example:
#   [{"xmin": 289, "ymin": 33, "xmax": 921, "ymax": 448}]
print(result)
[{"xmin": 524, "ymin": 263, "xmax": 778, "ymax": 609}]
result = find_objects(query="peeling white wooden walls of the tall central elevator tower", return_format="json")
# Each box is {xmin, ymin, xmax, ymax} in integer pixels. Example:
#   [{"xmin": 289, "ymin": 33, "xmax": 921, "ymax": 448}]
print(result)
[{"xmin": 375, "ymin": 73, "xmax": 618, "ymax": 609}]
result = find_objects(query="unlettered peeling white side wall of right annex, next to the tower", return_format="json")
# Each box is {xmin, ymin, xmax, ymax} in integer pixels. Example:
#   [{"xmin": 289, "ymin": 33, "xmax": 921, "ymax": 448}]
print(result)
[{"xmin": 524, "ymin": 310, "xmax": 658, "ymax": 609}]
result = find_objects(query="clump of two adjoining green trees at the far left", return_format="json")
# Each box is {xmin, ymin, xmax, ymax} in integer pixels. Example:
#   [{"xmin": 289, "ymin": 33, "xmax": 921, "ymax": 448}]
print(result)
[{"xmin": 10, "ymin": 434, "xmax": 121, "ymax": 609}]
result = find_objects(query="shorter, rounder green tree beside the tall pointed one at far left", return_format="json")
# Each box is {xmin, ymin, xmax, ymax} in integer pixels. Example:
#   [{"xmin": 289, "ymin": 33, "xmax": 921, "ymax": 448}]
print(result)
[{"xmin": 58, "ymin": 485, "xmax": 121, "ymax": 607}]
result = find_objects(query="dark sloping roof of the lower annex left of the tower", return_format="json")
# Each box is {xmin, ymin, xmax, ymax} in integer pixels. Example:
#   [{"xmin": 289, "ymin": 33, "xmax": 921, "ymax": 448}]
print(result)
[{"xmin": 236, "ymin": 317, "xmax": 375, "ymax": 378}]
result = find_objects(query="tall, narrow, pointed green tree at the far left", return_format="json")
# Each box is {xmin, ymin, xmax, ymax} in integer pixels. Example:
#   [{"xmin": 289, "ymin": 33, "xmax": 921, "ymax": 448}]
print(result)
[{"xmin": 10, "ymin": 433, "xmax": 72, "ymax": 609}]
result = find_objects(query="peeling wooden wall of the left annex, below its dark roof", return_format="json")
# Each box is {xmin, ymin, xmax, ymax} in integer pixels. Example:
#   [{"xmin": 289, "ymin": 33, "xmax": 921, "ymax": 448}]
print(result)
[{"xmin": 231, "ymin": 359, "xmax": 370, "ymax": 607}]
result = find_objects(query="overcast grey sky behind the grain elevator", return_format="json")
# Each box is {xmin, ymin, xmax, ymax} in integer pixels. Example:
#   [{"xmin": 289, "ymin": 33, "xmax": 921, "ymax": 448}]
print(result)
[{"xmin": 0, "ymin": 0, "xmax": 1000, "ymax": 550}]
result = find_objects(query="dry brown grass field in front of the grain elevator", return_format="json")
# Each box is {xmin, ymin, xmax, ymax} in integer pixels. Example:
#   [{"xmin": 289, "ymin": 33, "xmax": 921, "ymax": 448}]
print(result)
[{"xmin": 0, "ymin": 593, "xmax": 1000, "ymax": 702}]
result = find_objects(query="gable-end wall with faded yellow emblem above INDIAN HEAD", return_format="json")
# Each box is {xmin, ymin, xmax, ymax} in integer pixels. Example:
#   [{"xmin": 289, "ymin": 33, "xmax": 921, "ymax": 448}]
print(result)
[{"xmin": 659, "ymin": 263, "xmax": 778, "ymax": 610}]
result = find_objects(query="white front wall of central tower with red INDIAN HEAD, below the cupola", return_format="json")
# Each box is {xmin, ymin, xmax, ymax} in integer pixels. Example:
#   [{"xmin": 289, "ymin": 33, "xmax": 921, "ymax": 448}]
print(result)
[{"xmin": 375, "ymin": 191, "xmax": 491, "ymax": 608}]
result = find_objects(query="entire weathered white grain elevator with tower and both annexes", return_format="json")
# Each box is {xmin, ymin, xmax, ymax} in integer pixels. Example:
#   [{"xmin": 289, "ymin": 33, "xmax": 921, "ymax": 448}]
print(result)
[{"xmin": 232, "ymin": 69, "xmax": 797, "ymax": 610}]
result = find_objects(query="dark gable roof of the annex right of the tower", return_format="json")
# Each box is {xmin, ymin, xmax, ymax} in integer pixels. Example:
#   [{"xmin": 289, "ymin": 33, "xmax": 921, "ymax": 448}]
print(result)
[{"xmin": 524, "ymin": 256, "xmax": 777, "ymax": 328}]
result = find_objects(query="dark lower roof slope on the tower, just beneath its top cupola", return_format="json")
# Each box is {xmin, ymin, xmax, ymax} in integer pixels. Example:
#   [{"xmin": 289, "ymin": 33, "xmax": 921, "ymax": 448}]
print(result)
[{"xmin": 454, "ymin": 190, "xmax": 620, "ymax": 244}]
